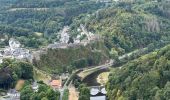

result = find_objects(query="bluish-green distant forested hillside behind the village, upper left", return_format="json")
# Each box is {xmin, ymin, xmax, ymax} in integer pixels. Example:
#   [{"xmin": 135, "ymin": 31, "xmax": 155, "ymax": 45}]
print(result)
[{"xmin": 0, "ymin": 0, "xmax": 103, "ymax": 48}]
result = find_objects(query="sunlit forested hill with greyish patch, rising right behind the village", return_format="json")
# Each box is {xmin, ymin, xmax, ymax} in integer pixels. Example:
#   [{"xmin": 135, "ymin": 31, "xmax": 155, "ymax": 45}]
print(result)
[{"xmin": 72, "ymin": 0, "xmax": 170, "ymax": 54}]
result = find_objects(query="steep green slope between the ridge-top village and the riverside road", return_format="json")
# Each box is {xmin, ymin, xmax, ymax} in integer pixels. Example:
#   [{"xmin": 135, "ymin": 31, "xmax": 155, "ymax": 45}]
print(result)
[{"xmin": 34, "ymin": 41, "xmax": 109, "ymax": 73}]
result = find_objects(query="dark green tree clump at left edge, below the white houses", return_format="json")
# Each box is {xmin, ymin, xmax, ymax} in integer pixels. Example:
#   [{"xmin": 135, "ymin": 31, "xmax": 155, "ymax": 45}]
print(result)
[{"xmin": 0, "ymin": 59, "xmax": 33, "ymax": 89}]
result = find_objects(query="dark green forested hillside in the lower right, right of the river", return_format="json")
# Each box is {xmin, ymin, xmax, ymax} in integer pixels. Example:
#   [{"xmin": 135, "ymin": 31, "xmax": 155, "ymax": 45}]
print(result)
[{"xmin": 107, "ymin": 45, "xmax": 170, "ymax": 100}]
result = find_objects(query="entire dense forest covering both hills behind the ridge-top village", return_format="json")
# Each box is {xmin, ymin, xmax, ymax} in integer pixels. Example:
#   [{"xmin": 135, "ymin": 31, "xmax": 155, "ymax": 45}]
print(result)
[{"xmin": 0, "ymin": 0, "xmax": 170, "ymax": 54}]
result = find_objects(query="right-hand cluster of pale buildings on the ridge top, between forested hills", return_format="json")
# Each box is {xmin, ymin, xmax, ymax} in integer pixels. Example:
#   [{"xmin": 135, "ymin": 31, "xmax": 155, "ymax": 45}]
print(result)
[{"xmin": 48, "ymin": 24, "xmax": 100, "ymax": 49}]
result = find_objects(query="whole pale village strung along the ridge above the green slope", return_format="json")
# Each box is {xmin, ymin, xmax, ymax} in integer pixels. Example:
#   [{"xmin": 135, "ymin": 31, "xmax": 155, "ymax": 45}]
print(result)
[{"xmin": 0, "ymin": 25, "xmax": 100, "ymax": 63}]
